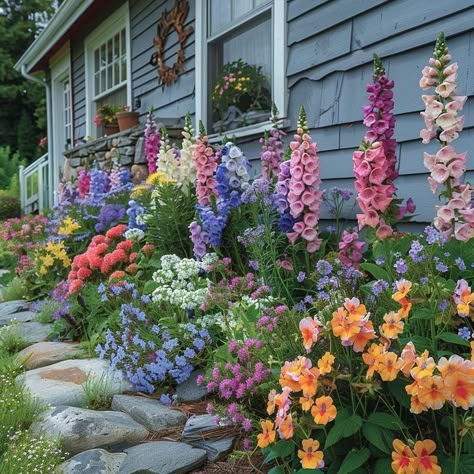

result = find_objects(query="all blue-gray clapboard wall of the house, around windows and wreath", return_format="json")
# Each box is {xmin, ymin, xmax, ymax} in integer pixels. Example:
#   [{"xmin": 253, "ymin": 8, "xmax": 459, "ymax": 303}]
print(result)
[{"xmin": 72, "ymin": 0, "xmax": 474, "ymax": 222}]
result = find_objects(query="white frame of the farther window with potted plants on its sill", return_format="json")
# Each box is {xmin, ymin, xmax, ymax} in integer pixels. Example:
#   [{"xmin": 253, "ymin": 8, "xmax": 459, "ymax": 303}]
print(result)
[{"xmin": 84, "ymin": 2, "xmax": 132, "ymax": 137}]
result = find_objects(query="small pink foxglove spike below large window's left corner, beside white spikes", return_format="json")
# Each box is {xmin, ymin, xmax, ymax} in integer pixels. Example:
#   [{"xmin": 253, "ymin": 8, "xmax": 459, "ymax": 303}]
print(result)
[{"xmin": 194, "ymin": 127, "xmax": 218, "ymax": 206}]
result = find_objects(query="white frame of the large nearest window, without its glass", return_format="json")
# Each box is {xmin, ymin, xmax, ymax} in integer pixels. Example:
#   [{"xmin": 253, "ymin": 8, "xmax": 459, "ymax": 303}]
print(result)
[{"xmin": 195, "ymin": 0, "xmax": 288, "ymax": 142}]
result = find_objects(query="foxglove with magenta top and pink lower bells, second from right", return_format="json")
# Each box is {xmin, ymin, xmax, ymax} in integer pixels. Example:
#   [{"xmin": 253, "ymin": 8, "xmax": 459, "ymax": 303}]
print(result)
[{"xmin": 352, "ymin": 56, "xmax": 407, "ymax": 236}]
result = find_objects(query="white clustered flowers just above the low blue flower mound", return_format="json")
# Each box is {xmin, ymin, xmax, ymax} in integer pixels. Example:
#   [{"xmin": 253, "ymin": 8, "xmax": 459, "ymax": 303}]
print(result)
[{"xmin": 153, "ymin": 255, "xmax": 209, "ymax": 309}]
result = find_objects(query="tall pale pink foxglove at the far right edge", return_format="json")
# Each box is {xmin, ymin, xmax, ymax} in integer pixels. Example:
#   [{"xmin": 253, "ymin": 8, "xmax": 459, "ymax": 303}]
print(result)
[{"xmin": 420, "ymin": 33, "xmax": 474, "ymax": 241}]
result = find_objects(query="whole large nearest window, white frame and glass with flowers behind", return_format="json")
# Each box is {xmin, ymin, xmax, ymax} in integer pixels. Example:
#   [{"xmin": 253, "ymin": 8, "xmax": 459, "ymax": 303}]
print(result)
[{"xmin": 196, "ymin": 0, "xmax": 286, "ymax": 136}]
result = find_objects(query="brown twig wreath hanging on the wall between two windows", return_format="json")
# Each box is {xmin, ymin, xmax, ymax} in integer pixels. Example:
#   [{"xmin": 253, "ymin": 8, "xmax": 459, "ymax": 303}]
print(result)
[{"xmin": 150, "ymin": 0, "xmax": 193, "ymax": 86}]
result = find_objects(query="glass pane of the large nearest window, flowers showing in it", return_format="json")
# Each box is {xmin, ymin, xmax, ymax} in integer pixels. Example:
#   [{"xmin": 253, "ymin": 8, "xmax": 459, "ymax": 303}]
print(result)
[{"xmin": 208, "ymin": 12, "xmax": 272, "ymax": 132}]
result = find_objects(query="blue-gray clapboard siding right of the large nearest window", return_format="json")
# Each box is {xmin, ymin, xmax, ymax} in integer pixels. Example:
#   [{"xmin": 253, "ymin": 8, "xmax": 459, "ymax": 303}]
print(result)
[{"xmin": 287, "ymin": 0, "xmax": 474, "ymax": 222}]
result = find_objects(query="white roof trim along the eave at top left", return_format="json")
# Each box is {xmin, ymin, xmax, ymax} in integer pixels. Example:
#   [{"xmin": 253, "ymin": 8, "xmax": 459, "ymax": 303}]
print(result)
[{"xmin": 15, "ymin": 0, "xmax": 94, "ymax": 71}]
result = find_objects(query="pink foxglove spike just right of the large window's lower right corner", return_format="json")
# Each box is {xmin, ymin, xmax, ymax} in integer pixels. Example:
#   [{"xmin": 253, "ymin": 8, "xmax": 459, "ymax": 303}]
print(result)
[{"xmin": 287, "ymin": 107, "xmax": 322, "ymax": 253}]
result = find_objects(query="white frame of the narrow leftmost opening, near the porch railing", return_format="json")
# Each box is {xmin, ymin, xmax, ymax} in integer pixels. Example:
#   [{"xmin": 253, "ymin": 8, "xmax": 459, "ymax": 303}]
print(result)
[{"xmin": 48, "ymin": 42, "xmax": 74, "ymax": 201}]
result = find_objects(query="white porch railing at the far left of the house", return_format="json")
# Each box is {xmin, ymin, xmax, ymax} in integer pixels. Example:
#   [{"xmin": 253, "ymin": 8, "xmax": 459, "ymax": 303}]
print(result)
[{"xmin": 19, "ymin": 153, "xmax": 50, "ymax": 214}]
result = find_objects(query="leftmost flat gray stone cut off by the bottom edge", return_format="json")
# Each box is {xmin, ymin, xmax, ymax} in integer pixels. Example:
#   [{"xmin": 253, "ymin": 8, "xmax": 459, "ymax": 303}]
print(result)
[{"xmin": 59, "ymin": 449, "xmax": 127, "ymax": 474}]
